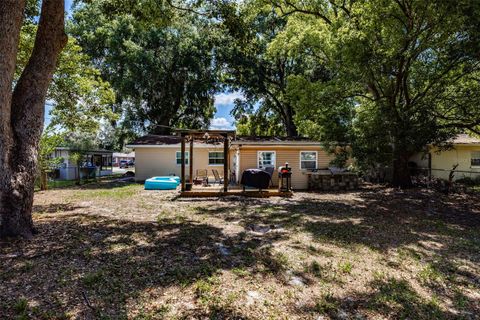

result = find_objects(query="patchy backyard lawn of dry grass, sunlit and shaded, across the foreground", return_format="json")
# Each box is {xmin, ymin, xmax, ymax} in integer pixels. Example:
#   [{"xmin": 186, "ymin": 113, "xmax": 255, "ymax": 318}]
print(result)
[{"xmin": 0, "ymin": 182, "xmax": 480, "ymax": 319}]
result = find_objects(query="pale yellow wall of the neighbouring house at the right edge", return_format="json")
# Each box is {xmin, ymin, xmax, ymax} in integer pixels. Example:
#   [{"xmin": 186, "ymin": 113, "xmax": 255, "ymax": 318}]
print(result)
[{"xmin": 411, "ymin": 145, "xmax": 480, "ymax": 179}]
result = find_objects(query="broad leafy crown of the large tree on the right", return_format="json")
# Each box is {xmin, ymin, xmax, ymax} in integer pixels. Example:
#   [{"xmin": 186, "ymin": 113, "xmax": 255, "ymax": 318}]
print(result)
[{"xmin": 269, "ymin": 0, "xmax": 480, "ymax": 185}]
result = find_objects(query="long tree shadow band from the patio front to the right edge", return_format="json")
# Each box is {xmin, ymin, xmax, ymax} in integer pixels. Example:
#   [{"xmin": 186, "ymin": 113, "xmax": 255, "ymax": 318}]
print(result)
[{"xmin": 184, "ymin": 189, "xmax": 480, "ymax": 262}]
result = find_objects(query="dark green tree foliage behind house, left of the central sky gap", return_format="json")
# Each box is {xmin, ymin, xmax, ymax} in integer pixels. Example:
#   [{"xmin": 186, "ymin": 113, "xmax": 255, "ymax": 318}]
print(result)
[{"xmin": 71, "ymin": 0, "xmax": 217, "ymax": 136}]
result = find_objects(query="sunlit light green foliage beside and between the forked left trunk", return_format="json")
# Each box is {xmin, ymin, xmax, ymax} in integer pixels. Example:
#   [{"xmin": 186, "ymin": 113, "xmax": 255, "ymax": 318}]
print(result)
[{"xmin": 15, "ymin": 21, "xmax": 117, "ymax": 132}]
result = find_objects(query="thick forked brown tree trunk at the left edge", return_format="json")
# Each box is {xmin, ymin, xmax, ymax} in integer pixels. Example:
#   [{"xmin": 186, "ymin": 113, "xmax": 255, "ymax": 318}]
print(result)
[{"xmin": 0, "ymin": 0, "xmax": 67, "ymax": 238}]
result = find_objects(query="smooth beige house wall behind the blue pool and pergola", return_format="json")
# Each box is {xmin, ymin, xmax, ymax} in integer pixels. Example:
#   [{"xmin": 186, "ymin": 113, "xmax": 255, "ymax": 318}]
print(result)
[{"xmin": 135, "ymin": 145, "xmax": 233, "ymax": 181}]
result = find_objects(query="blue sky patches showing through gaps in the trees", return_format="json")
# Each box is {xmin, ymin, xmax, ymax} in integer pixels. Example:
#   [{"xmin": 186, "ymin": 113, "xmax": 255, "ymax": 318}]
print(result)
[{"xmin": 45, "ymin": 0, "xmax": 237, "ymax": 129}]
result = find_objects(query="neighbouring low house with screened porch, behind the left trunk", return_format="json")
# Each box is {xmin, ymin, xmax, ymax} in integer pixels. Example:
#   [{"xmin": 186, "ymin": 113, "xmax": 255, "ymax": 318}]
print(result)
[{"xmin": 51, "ymin": 147, "xmax": 113, "ymax": 180}]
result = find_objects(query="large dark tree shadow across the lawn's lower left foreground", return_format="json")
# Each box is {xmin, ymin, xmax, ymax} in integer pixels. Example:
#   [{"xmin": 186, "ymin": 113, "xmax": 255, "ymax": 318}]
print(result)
[{"xmin": 0, "ymin": 213, "xmax": 280, "ymax": 319}]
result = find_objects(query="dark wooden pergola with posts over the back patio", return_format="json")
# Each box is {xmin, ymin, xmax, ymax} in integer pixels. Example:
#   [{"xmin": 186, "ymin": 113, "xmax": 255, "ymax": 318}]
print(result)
[{"xmin": 175, "ymin": 129, "xmax": 235, "ymax": 192}]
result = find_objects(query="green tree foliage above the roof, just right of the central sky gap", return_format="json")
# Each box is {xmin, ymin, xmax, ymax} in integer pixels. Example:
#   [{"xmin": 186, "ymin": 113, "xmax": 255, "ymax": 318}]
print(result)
[{"xmin": 218, "ymin": 1, "xmax": 319, "ymax": 136}]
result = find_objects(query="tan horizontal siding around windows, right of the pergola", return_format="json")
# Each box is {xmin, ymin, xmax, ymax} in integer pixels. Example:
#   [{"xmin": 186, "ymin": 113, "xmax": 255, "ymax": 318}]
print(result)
[{"xmin": 236, "ymin": 145, "xmax": 333, "ymax": 190}]
